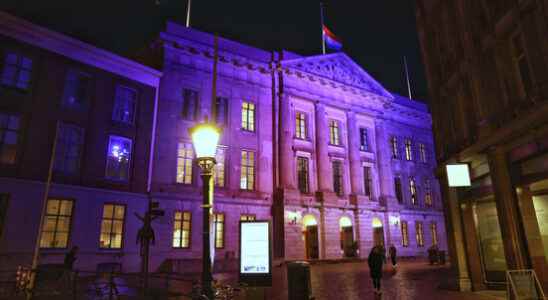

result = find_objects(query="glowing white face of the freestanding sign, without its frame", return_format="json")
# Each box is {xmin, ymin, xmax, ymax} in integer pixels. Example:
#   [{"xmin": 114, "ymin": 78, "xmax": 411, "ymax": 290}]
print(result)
[{"xmin": 240, "ymin": 222, "xmax": 270, "ymax": 274}]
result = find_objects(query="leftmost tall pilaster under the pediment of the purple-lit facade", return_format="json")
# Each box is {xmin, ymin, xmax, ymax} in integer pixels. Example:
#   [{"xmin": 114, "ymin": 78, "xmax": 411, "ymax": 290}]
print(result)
[{"xmin": 280, "ymin": 93, "xmax": 297, "ymax": 189}]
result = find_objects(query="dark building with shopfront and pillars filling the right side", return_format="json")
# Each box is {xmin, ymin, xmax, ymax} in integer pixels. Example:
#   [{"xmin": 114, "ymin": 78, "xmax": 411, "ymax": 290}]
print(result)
[{"xmin": 416, "ymin": 0, "xmax": 548, "ymax": 290}]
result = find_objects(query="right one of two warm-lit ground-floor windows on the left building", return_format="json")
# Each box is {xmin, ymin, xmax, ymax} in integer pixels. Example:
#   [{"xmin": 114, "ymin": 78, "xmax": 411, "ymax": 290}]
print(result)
[{"xmin": 99, "ymin": 204, "xmax": 126, "ymax": 249}]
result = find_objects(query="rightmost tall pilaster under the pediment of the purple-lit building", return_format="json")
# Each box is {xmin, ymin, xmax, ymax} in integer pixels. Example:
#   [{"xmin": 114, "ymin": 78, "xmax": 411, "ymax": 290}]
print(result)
[{"xmin": 375, "ymin": 119, "xmax": 397, "ymax": 203}]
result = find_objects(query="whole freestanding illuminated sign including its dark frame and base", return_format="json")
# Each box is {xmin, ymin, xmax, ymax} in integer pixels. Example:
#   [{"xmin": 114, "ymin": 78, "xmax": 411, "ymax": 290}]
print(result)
[{"xmin": 239, "ymin": 221, "xmax": 272, "ymax": 286}]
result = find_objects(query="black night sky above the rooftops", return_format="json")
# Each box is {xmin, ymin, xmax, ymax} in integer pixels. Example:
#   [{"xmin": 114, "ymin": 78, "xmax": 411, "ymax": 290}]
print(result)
[{"xmin": 0, "ymin": 0, "xmax": 426, "ymax": 99}]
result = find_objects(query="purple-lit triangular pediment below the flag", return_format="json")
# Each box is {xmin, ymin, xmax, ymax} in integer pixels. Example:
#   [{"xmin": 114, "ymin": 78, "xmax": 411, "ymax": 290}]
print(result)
[{"xmin": 282, "ymin": 52, "xmax": 393, "ymax": 98}]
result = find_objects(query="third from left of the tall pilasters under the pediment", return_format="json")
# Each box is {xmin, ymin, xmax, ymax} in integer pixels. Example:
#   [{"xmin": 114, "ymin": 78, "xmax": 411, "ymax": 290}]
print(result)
[{"xmin": 346, "ymin": 111, "xmax": 363, "ymax": 195}]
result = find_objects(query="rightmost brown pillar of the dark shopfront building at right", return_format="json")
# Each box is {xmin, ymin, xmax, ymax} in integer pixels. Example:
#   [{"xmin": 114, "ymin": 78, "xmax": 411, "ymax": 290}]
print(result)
[{"xmin": 518, "ymin": 186, "xmax": 548, "ymax": 291}]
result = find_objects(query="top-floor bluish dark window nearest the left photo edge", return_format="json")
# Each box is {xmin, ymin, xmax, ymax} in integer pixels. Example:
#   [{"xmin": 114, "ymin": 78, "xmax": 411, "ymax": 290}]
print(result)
[{"xmin": 0, "ymin": 52, "xmax": 32, "ymax": 90}]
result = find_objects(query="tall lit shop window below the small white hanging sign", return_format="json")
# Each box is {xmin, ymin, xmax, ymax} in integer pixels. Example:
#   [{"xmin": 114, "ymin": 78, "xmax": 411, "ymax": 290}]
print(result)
[{"xmin": 474, "ymin": 198, "xmax": 506, "ymax": 282}]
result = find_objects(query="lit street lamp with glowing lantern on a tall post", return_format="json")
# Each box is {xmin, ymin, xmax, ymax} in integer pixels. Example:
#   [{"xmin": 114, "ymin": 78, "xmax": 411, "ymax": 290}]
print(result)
[{"xmin": 189, "ymin": 120, "xmax": 221, "ymax": 299}]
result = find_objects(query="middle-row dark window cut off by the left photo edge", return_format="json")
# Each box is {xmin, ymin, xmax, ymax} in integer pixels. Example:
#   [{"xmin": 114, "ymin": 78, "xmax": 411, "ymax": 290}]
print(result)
[{"xmin": 0, "ymin": 113, "xmax": 20, "ymax": 165}]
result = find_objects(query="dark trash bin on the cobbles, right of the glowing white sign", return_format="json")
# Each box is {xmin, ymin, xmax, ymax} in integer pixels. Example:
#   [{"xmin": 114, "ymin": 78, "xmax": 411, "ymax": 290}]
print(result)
[{"xmin": 287, "ymin": 261, "xmax": 313, "ymax": 300}]
